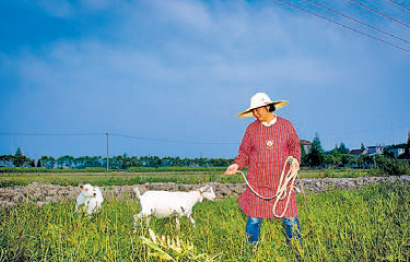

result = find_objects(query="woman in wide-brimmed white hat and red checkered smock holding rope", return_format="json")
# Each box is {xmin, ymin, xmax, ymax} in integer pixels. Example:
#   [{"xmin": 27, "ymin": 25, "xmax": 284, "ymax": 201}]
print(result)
[{"xmin": 225, "ymin": 93, "xmax": 301, "ymax": 244}]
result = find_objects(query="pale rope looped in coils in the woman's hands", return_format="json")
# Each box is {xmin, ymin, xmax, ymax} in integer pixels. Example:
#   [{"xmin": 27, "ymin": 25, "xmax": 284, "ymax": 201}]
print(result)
[{"xmin": 237, "ymin": 156, "xmax": 303, "ymax": 218}]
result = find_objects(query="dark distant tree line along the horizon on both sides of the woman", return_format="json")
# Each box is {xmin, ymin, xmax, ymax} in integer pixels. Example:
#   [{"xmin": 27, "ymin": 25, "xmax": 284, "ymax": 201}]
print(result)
[{"xmin": 0, "ymin": 134, "xmax": 410, "ymax": 169}]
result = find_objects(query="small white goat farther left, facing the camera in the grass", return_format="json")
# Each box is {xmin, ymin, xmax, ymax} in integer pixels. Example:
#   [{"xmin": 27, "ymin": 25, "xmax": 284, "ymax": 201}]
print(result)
[{"xmin": 75, "ymin": 184, "xmax": 104, "ymax": 215}]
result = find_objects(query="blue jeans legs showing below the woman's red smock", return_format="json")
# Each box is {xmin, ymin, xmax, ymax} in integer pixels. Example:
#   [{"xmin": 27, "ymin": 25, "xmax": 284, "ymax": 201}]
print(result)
[{"xmin": 245, "ymin": 217, "xmax": 302, "ymax": 244}]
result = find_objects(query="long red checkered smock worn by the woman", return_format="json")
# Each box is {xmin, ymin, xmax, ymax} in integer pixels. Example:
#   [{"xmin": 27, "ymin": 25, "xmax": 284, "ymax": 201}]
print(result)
[{"xmin": 233, "ymin": 117, "xmax": 301, "ymax": 218}]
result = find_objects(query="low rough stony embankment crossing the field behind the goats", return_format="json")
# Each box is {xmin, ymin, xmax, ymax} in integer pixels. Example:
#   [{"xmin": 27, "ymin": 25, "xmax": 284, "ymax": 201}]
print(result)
[{"xmin": 0, "ymin": 176, "xmax": 410, "ymax": 210}]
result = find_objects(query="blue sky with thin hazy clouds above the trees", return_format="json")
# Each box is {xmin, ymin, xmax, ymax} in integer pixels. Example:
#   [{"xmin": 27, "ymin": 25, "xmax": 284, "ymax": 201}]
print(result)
[{"xmin": 0, "ymin": 0, "xmax": 410, "ymax": 158}]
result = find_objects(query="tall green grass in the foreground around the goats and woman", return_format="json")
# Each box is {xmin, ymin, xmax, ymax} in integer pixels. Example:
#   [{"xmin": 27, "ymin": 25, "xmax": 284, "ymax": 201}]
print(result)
[{"xmin": 0, "ymin": 184, "xmax": 410, "ymax": 262}]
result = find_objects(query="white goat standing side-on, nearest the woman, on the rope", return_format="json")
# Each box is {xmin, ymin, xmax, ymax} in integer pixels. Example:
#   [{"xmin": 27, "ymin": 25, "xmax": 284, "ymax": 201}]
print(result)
[{"xmin": 134, "ymin": 186, "xmax": 216, "ymax": 229}]
